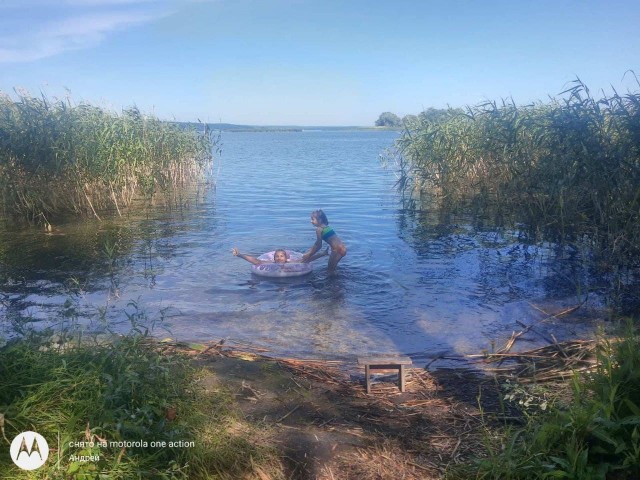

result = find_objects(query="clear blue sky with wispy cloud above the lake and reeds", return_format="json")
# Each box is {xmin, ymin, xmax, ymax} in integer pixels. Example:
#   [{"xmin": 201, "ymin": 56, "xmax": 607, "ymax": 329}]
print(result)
[{"xmin": 0, "ymin": 0, "xmax": 640, "ymax": 125}]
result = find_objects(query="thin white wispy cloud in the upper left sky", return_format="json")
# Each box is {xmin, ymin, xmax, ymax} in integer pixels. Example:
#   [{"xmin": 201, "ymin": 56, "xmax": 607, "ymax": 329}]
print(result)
[{"xmin": 0, "ymin": 0, "xmax": 175, "ymax": 63}]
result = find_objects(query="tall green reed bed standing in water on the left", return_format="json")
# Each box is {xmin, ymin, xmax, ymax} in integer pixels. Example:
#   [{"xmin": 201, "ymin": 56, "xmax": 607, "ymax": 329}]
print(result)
[{"xmin": 0, "ymin": 92, "xmax": 215, "ymax": 226}]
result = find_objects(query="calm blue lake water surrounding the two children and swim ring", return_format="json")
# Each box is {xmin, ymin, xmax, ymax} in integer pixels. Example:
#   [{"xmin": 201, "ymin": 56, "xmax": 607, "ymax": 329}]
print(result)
[{"xmin": 0, "ymin": 130, "xmax": 598, "ymax": 364}]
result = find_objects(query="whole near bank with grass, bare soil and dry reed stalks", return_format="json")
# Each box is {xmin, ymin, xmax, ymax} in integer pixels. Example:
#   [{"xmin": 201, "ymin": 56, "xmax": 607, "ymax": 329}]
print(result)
[{"xmin": 0, "ymin": 327, "xmax": 640, "ymax": 480}]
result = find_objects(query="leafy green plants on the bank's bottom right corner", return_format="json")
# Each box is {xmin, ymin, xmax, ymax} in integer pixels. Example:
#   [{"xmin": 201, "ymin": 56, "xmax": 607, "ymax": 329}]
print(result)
[{"xmin": 449, "ymin": 324, "xmax": 640, "ymax": 480}]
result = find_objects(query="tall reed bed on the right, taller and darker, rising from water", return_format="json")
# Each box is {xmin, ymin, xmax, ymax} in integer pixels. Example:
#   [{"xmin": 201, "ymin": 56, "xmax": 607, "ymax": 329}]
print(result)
[{"xmin": 395, "ymin": 78, "xmax": 640, "ymax": 306}]
